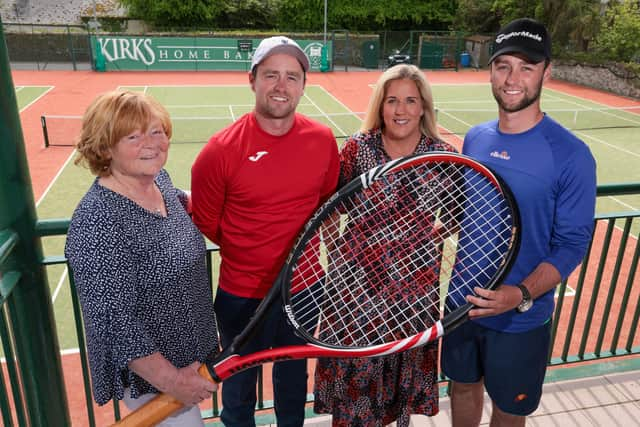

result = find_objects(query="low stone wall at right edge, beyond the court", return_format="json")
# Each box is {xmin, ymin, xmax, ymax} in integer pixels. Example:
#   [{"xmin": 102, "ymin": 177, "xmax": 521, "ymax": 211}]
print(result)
[{"xmin": 552, "ymin": 60, "xmax": 640, "ymax": 99}]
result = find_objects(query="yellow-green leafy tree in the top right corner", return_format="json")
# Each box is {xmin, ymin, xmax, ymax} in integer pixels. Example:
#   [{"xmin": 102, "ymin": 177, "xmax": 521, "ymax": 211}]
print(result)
[{"xmin": 595, "ymin": 0, "xmax": 640, "ymax": 62}]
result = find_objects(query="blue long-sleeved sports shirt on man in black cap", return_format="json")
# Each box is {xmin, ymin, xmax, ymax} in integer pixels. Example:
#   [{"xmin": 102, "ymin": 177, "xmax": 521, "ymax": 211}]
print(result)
[{"xmin": 463, "ymin": 115, "xmax": 596, "ymax": 332}]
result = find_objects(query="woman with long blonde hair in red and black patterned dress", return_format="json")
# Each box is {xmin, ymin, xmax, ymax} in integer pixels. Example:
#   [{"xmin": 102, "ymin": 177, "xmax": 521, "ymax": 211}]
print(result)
[{"xmin": 314, "ymin": 64, "xmax": 456, "ymax": 427}]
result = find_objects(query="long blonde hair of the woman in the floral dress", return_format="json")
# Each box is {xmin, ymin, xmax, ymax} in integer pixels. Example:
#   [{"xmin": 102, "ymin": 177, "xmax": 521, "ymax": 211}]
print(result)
[{"xmin": 360, "ymin": 64, "xmax": 442, "ymax": 139}]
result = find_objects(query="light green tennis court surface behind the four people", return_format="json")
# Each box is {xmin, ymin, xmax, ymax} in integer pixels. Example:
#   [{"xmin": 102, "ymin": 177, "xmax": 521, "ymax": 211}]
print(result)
[{"xmin": 17, "ymin": 84, "xmax": 640, "ymax": 349}]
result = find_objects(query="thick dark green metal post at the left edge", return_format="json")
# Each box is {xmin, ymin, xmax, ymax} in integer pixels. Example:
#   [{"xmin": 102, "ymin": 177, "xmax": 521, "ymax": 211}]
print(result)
[{"xmin": 0, "ymin": 16, "xmax": 71, "ymax": 427}]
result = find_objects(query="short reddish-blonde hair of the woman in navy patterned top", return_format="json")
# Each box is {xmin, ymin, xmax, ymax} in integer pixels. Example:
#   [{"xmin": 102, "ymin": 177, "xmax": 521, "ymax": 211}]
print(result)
[{"xmin": 75, "ymin": 90, "xmax": 172, "ymax": 177}]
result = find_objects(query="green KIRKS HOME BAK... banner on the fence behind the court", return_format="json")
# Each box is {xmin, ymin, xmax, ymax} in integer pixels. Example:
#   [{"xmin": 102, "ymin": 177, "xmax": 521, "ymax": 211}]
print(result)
[{"xmin": 91, "ymin": 36, "xmax": 331, "ymax": 71}]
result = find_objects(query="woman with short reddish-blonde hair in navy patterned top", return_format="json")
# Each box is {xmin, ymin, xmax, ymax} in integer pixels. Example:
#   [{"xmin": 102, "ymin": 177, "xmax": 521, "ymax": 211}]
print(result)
[{"xmin": 65, "ymin": 91, "xmax": 218, "ymax": 426}]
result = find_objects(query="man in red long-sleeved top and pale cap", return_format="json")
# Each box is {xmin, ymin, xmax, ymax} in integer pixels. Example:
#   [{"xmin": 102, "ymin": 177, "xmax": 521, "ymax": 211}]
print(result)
[{"xmin": 191, "ymin": 36, "xmax": 339, "ymax": 427}]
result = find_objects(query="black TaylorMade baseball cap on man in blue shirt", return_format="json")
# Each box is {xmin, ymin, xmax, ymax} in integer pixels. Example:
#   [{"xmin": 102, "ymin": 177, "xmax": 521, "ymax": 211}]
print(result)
[{"xmin": 489, "ymin": 18, "xmax": 551, "ymax": 64}]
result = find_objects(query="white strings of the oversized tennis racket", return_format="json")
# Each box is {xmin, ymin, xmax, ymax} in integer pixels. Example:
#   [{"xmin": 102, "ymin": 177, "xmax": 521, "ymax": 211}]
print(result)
[{"xmin": 290, "ymin": 162, "xmax": 511, "ymax": 347}]
